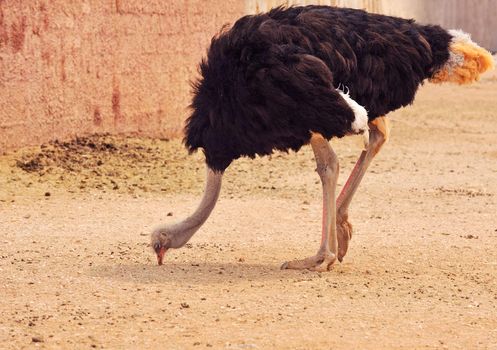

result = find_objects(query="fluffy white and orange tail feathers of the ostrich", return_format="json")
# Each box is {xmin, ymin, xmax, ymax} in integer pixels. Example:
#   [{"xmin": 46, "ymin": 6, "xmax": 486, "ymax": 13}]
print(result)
[{"xmin": 430, "ymin": 30, "xmax": 495, "ymax": 85}]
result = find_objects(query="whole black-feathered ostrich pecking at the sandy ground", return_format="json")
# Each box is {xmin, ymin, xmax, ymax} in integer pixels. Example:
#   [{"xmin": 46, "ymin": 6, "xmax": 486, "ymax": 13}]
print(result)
[{"xmin": 151, "ymin": 6, "xmax": 494, "ymax": 271}]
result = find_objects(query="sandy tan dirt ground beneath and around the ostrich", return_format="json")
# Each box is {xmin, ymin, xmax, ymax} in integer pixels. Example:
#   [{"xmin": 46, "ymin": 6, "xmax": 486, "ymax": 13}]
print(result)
[{"xmin": 0, "ymin": 69, "xmax": 497, "ymax": 349}]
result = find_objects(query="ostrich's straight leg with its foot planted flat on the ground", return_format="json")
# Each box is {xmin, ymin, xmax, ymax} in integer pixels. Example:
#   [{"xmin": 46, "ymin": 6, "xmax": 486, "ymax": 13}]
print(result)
[{"xmin": 281, "ymin": 133, "xmax": 338, "ymax": 271}]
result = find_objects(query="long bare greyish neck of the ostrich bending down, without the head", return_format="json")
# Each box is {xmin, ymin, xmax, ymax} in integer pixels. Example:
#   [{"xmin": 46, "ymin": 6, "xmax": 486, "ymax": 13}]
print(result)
[{"xmin": 169, "ymin": 167, "xmax": 223, "ymax": 248}]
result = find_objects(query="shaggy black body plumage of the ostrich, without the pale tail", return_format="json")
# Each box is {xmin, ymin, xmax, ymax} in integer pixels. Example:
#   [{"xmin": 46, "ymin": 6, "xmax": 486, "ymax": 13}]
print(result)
[{"xmin": 184, "ymin": 6, "xmax": 451, "ymax": 171}]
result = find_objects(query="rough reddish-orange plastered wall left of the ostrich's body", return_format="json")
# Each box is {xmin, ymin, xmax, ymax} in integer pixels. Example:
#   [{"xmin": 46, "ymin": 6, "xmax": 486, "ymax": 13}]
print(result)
[{"xmin": 0, "ymin": 0, "xmax": 245, "ymax": 152}]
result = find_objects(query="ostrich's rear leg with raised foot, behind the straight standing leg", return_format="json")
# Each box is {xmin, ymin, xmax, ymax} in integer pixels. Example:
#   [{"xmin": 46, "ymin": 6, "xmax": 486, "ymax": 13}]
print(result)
[{"xmin": 337, "ymin": 117, "xmax": 390, "ymax": 262}]
